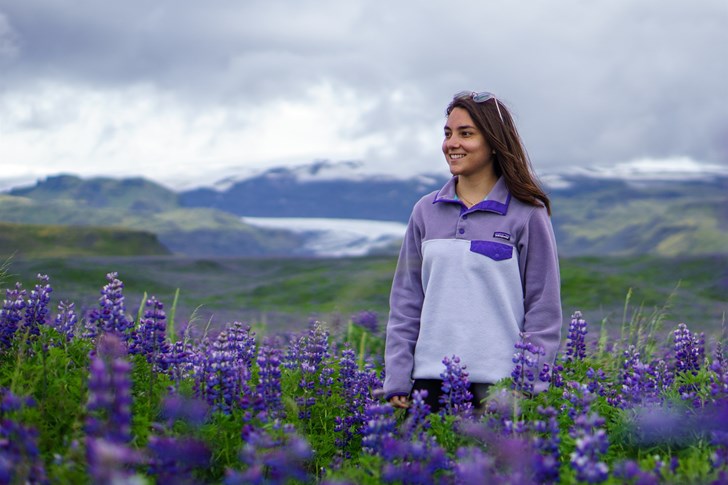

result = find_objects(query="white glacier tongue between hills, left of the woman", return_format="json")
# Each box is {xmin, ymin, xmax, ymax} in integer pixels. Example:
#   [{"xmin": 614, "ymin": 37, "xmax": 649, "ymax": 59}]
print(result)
[{"xmin": 242, "ymin": 217, "xmax": 407, "ymax": 257}]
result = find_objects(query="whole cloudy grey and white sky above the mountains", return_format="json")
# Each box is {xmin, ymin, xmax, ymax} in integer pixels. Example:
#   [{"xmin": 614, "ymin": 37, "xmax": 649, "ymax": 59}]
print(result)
[{"xmin": 0, "ymin": 0, "xmax": 728, "ymax": 184}]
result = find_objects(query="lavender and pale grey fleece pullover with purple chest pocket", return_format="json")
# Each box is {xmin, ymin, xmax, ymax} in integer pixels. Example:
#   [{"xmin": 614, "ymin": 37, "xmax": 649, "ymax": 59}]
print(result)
[{"xmin": 384, "ymin": 177, "xmax": 562, "ymax": 399}]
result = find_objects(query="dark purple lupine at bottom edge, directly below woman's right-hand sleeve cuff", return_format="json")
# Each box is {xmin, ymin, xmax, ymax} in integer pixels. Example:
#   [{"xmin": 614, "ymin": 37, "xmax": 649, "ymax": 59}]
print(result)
[{"xmin": 533, "ymin": 406, "xmax": 561, "ymax": 483}]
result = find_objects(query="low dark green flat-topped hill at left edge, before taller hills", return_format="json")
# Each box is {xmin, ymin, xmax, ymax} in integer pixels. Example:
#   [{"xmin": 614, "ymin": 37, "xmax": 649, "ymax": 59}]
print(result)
[{"xmin": 0, "ymin": 222, "xmax": 169, "ymax": 258}]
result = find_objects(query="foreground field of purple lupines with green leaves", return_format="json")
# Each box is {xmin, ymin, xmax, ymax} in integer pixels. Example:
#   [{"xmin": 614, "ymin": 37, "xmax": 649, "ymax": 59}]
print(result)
[{"xmin": 0, "ymin": 273, "xmax": 728, "ymax": 484}]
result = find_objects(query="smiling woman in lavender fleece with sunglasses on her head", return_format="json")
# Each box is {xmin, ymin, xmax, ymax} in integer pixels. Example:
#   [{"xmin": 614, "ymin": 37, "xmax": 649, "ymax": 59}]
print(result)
[{"xmin": 384, "ymin": 91, "xmax": 562, "ymax": 411}]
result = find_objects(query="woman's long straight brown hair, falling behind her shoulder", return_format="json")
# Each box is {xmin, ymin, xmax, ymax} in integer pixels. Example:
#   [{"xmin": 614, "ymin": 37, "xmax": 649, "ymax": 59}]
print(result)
[{"xmin": 446, "ymin": 96, "xmax": 551, "ymax": 215}]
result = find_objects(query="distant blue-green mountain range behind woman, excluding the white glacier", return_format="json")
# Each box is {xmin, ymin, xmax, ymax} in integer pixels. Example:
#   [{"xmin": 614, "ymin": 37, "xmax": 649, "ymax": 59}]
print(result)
[{"xmin": 0, "ymin": 162, "xmax": 728, "ymax": 257}]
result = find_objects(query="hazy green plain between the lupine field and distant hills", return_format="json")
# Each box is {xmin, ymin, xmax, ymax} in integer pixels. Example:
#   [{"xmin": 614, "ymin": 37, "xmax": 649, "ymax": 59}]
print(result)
[{"xmin": 5, "ymin": 256, "xmax": 728, "ymax": 340}]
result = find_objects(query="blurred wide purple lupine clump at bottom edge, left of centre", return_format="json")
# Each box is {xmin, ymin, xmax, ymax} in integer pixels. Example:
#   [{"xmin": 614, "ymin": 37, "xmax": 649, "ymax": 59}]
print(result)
[{"xmin": 224, "ymin": 425, "xmax": 312, "ymax": 485}]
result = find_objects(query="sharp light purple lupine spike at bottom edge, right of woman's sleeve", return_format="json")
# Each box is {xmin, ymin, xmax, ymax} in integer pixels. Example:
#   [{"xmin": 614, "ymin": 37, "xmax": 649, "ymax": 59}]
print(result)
[{"xmin": 569, "ymin": 412, "xmax": 609, "ymax": 483}]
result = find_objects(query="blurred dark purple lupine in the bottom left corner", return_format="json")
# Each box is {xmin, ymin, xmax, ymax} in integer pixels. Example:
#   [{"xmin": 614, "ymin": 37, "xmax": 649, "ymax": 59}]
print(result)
[{"xmin": 0, "ymin": 388, "xmax": 46, "ymax": 483}]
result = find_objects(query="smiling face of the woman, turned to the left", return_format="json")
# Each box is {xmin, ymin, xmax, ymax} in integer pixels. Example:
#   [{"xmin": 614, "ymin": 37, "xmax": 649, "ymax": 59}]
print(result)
[{"xmin": 442, "ymin": 108, "xmax": 493, "ymax": 177}]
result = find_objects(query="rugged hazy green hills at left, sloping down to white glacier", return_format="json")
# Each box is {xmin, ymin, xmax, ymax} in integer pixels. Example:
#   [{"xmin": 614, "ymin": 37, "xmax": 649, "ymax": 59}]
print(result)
[{"xmin": 0, "ymin": 175, "xmax": 299, "ymax": 256}]
